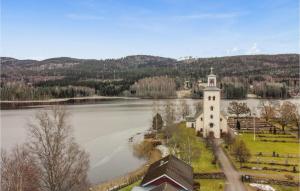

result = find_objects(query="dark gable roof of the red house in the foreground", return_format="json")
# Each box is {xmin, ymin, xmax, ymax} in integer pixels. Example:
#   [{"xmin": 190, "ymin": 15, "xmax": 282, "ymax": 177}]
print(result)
[{"xmin": 141, "ymin": 155, "xmax": 193, "ymax": 190}]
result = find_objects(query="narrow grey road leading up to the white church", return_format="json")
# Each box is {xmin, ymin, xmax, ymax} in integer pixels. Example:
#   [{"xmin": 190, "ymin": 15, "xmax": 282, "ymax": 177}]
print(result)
[{"xmin": 214, "ymin": 139, "xmax": 247, "ymax": 191}]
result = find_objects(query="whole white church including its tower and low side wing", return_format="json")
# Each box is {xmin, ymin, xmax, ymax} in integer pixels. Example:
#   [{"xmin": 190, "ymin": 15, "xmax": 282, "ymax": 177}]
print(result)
[{"xmin": 186, "ymin": 68, "xmax": 227, "ymax": 138}]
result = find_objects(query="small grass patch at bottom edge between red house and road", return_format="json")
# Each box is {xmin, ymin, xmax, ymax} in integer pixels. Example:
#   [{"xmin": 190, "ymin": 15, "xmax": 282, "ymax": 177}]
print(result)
[{"xmin": 197, "ymin": 179, "xmax": 225, "ymax": 191}]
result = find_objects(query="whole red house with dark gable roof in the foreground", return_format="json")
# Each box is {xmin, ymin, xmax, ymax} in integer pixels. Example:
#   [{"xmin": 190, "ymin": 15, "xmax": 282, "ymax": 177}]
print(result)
[{"xmin": 133, "ymin": 155, "xmax": 194, "ymax": 191}]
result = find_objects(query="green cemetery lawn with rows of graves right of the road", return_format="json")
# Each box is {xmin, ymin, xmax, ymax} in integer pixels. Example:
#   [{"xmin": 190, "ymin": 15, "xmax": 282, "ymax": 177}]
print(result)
[{"xmin": 230, "ymin": 133, "xmax": 300, "ymax": 181}]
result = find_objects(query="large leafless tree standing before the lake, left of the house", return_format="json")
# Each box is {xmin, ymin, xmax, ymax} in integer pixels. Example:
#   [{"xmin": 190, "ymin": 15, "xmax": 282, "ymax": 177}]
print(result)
[{"xmin": 28, "ymin": 106, "xmax": 89, "ymax": 191}]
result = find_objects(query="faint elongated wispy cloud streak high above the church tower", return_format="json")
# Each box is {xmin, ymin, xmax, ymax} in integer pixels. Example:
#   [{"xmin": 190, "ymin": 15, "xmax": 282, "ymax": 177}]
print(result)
[{"xmin": 174, "ymin": 13, "xmax": 240, "ymax": 20}]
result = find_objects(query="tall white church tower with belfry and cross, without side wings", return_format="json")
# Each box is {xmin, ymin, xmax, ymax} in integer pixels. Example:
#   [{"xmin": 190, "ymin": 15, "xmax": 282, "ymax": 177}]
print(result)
[{"xmin": 203, "ymin": 68, "xmax": 221, "ymax": 138}]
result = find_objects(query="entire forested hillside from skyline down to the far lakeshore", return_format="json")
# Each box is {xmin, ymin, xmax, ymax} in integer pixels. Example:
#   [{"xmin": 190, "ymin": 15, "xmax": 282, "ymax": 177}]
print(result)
[{"xmin": 1, "ymin": 54, "xmax": 300, "ymax": 100}]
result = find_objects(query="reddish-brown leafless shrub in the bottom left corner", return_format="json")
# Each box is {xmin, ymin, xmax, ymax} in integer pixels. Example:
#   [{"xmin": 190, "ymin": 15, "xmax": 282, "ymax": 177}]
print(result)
[{"xmin": 1, "ymin": 146, "xmax": 41, "ymax": 191}]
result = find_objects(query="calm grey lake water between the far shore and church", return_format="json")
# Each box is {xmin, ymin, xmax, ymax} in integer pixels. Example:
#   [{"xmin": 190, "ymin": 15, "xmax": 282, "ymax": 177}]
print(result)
[{"xmin": 1, "ymin": 99, "xmax": 300, "ymax": 184}]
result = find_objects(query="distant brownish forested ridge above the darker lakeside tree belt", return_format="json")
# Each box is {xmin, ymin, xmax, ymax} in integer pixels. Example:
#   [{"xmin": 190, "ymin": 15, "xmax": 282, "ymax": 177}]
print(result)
[{"xmin": 1, "ymin": 54, "xmax": 299, "ymax": 83}]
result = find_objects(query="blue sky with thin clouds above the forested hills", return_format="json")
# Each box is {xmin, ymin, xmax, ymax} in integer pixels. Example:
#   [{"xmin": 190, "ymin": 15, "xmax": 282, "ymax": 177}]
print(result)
[{"xmin": 1, "ymin": 0, "xmax": 300, "ymax": 60}]
